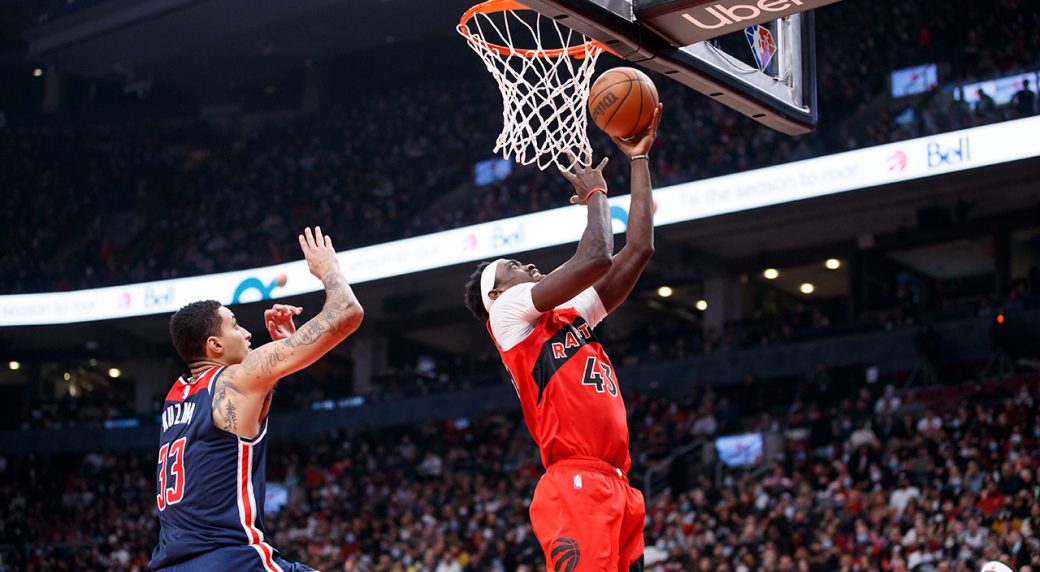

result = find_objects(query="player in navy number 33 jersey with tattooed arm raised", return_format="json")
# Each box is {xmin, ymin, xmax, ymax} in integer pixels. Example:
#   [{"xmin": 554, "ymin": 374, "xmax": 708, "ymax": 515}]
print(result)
[{"xmin": 149, "ymin": 227, "xmax": 364, "ymax": 572}]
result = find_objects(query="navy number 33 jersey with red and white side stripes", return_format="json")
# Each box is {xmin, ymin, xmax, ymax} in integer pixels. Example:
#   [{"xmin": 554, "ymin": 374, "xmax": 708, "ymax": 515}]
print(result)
[{"xmin": 149, "ymin": 367, "xmax": 282, "ymax": 572}]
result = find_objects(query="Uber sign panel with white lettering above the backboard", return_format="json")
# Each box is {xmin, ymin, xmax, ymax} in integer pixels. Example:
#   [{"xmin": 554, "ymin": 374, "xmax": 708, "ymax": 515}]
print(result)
[{"xmin": 635, "ymin": 0, "xmax": 837, "ymax": 47}]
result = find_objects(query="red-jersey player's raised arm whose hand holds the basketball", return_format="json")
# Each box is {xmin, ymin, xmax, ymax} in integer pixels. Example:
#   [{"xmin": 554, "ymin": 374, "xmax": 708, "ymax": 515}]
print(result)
[{"xmin": 596, "ymin": 103, "xmax": 664, "ymax": 312}]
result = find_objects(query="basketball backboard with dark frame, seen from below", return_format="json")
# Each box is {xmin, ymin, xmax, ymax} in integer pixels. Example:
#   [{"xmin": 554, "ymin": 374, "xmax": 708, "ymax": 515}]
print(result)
[{"xmin": 523, "ymin": 0, "xmax": 837, "ymax": 135}]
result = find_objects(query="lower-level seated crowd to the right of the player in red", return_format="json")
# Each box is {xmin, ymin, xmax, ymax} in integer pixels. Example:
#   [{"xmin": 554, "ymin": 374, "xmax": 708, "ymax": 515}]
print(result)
[{"xmin": 648, "ymin": 379, "xmax": 1040, "ymax": 572}]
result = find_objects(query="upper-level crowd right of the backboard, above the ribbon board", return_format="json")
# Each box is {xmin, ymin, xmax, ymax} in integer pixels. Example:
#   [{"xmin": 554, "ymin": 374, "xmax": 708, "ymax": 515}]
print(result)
[{"xmin": 836, "ymin": 0, "xmax": 1040, "ymax": 147}]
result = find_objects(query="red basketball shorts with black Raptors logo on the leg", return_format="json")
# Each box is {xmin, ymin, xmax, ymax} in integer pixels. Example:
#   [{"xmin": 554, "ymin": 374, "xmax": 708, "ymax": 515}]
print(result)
[{"xmin": 530, "ymin": 458, "xmax": 646, "ymax": 572}]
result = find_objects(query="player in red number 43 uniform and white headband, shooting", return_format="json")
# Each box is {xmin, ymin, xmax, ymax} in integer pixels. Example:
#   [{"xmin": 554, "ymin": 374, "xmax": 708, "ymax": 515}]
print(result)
[{"xmin": 466, "ymin": 105, "xmax": 661, "ymax": 572}]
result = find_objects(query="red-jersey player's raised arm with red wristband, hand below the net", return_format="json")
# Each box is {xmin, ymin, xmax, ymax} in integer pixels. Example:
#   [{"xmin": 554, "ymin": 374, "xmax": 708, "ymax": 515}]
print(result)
[{"xmin": 530, "ymin": 158, "xmax": 614, "ymax": 312}]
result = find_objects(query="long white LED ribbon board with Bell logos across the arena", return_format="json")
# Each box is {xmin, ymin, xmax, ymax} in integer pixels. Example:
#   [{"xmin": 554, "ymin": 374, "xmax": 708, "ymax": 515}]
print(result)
[{"xmin": 0, "ymin": 116, "xmax": 1040, "ymax": 327}]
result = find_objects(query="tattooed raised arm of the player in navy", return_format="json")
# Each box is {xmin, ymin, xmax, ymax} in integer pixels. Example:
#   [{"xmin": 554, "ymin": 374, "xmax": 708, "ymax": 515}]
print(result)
[{"xmin": 213, "ymin": 228, "xmax": 364, "ymax": 437}]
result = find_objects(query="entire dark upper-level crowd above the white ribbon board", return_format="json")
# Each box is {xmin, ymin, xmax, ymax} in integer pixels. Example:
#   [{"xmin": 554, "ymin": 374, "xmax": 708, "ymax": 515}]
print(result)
[{"xmin": 0, "ymin": 0, "xmax": 1040, "ymax": 293}]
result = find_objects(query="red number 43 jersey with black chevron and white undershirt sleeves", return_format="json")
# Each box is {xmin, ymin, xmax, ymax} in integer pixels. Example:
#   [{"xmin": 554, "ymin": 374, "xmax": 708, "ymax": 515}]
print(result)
[{"xmin": 488, "ymin": 283, "xmax": 631, "ymax": 472}]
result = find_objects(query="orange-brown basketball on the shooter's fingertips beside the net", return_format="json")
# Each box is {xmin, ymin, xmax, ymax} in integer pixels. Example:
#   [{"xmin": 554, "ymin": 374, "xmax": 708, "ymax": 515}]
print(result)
[{"xmin": 589, "ymin": 68, "xmax": 658, "ymax": 138}]
